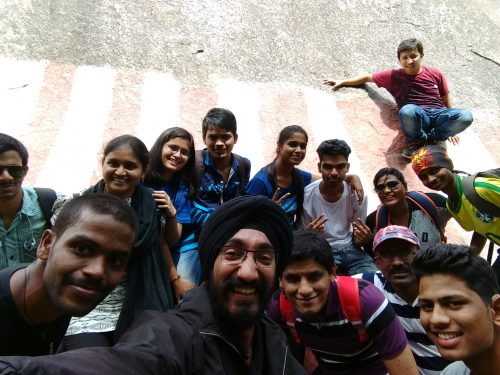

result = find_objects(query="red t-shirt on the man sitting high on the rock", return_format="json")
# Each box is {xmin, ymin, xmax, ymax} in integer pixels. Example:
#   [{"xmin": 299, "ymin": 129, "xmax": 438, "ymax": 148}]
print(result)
[{"xmin": 372, "ymin": 66, "xmax": 448, "ymax": 108}]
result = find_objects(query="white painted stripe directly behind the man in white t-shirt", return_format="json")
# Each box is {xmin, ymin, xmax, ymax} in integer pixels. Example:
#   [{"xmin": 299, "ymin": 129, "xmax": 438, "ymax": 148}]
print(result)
[{"xmin": 303, "ymin": 87, "xmax": 380, "ymax": 213}]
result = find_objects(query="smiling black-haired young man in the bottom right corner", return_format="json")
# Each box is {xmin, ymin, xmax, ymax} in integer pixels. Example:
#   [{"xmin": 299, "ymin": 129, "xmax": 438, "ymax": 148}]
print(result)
[{"xmin": 413, "ymin": 244, "xmax": 500, "ymax": 375}]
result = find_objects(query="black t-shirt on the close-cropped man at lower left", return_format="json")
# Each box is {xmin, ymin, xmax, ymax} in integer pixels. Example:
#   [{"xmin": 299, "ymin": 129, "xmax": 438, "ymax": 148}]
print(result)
[{"xmin": 0, "ymin": 264, "xmax": 70, "ymax": 356}]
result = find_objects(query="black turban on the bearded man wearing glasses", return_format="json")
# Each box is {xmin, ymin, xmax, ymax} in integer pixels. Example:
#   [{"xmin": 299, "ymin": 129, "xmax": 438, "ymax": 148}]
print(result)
[{"xmin": 198, "ymin": 196, "xmax": 293, "ymax": 281}]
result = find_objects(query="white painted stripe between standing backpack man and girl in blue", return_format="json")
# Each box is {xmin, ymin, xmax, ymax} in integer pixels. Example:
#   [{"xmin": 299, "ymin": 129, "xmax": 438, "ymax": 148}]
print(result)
[{"xmin": 215, "ymin": 79, "xmax": 264, "ymax": 177}]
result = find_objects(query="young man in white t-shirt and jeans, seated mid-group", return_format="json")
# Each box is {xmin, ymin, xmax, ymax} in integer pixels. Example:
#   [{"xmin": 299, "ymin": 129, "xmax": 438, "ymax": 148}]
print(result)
[{"xmin": 302, "ymin": 139, "xmax": 377, "ymax": 275}]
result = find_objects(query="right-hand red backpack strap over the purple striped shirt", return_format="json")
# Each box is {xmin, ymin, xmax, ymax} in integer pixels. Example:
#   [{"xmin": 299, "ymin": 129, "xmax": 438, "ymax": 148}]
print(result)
[{"xmin": 336, "ymin": 276, "xmax": 368, "ymax": 343}]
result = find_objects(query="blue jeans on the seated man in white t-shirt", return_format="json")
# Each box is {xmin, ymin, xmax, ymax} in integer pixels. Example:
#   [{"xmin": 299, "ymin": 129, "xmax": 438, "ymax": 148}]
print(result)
[{"xmin": 332, "ymin": 244, "xmax": 378, "ymax": 275}]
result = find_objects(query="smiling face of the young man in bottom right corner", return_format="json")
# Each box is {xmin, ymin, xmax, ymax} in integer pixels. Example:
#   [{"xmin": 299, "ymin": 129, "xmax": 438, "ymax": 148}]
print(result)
[{"xmin": 419, "ymin": 273, "xmax": 495, "ymax": 361}]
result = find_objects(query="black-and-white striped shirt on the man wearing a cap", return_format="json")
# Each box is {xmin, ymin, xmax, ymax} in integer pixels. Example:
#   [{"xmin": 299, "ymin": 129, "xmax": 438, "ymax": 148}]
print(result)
[{"xmin": 354, "ymin": 271, "xmax": 450, "ymax": 375}]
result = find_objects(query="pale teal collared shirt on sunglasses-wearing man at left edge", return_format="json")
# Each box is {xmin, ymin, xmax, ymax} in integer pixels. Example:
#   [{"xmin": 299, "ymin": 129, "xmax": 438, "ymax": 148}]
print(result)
[{"xmin": 0, "ymin": 187, "xmax": 46, "ymax": 269}]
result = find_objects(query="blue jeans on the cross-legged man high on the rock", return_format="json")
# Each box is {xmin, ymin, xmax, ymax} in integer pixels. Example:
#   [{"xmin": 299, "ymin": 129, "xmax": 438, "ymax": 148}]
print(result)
[{"xmin": 399, "ymin": 104, "xmax": 472, "ymax": 142}]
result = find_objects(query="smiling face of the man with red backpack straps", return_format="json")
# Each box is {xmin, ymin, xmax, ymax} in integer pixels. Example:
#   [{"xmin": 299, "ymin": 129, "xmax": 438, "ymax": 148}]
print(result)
[{"xmin": 280, "ymin": 259, "xmax": 335, "ymax": 319}]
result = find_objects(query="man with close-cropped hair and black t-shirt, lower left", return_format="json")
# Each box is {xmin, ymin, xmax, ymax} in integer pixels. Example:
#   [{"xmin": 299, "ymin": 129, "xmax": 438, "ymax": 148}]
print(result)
[{"xmin": 0, "ymin": 194, "xmax": 137, "ymax": 356}]
